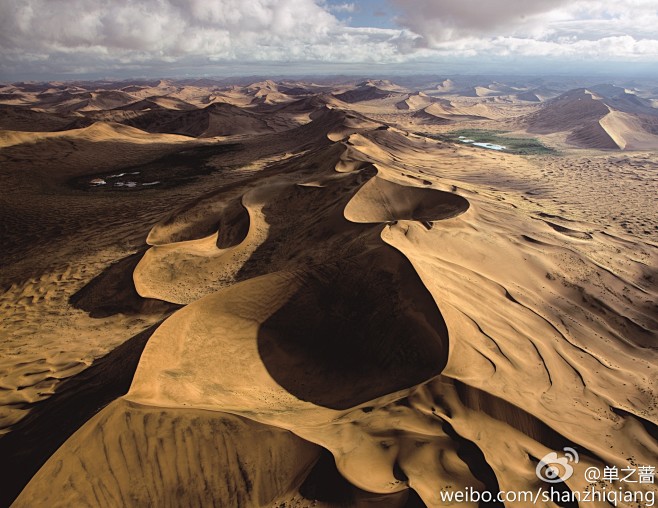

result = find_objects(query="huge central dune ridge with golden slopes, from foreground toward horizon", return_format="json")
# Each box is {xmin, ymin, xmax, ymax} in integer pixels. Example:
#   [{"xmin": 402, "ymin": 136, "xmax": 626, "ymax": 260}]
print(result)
[{"xmin": 16, "ymin": 109, "xmax": 658, "ymax": 507}]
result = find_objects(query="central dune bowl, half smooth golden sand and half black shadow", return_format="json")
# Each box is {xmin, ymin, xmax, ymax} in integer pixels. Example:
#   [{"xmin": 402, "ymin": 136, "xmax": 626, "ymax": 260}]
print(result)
[{"xmin": 128, "ymin": 245, "xmax": 448, "ymax": 412}]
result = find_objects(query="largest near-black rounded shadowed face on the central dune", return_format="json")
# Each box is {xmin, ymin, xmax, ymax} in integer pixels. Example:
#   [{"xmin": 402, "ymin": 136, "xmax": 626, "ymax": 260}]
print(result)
[{"xmin": 258, "ymin": 246, "xmax": 448, "ymax": 409}]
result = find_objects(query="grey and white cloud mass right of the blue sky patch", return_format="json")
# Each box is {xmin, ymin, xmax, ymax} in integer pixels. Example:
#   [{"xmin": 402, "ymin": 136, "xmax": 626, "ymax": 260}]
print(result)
[{"xmin": 386, "ymin": 0, "xmax": 658, "ymax": 61}]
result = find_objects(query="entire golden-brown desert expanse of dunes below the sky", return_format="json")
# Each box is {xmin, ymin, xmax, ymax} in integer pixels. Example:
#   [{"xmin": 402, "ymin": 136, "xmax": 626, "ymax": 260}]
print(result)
[{"xmin": 0, "ymin": 76, "xmax": 658, "ymax": 508}]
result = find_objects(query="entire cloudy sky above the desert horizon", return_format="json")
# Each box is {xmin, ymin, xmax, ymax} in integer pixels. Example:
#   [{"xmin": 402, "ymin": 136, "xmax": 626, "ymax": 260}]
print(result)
[{"xmin": 0, "ymin": 0, "xmax": 658, "ymax": 80}]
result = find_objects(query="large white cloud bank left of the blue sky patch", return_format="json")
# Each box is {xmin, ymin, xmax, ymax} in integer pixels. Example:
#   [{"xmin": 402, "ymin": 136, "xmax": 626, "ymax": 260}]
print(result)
[{"xmin": 0, "ymin": 0, "xmax": 407, "ymax": 73}]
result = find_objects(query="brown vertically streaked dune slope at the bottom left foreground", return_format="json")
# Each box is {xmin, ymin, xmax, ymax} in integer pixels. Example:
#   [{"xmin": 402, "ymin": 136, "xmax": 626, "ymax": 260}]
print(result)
[{"xmin": 13, "ymin": 401, "xmax": 317, "ymax": 507}]
